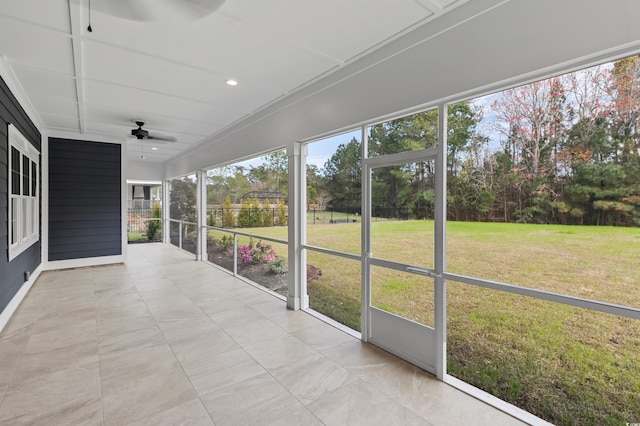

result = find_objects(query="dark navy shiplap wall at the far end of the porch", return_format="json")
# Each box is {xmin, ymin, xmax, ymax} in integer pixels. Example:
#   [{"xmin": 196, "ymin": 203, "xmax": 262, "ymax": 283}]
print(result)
[{"xmin": 49, "ymin": 138, "xmax": 122, "ymax": 261}]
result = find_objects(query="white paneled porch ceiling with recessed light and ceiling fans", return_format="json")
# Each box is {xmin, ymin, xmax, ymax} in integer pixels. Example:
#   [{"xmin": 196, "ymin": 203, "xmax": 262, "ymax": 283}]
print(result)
[{"xmin": 0, "ymin": 0, "xmax": 467, "ymax": 162}]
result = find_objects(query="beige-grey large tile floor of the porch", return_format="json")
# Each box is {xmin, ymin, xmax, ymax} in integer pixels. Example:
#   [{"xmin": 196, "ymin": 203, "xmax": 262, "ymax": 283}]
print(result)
[{"xmin": 0, "ymin": 244, "xmax": 521, "ymax": 425}]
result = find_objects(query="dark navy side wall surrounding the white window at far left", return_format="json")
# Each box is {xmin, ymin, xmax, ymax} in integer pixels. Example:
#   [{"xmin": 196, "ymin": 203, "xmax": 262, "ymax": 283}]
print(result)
[{"xmin": 0, "ymin": 78, "xmax": 42, "ymax": 312}]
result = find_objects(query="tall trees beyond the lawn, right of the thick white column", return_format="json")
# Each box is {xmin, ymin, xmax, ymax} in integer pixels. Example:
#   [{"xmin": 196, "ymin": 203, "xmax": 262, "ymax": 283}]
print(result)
[{"xmin": 314, "ymin": 57, "xmax": 640, "ymax": 226}]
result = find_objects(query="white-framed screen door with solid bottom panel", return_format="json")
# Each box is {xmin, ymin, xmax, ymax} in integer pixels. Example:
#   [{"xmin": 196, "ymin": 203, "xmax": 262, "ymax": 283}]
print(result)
[{"xmin": 363, "ymin": 148, "xmax": 441, "ymax": 374}]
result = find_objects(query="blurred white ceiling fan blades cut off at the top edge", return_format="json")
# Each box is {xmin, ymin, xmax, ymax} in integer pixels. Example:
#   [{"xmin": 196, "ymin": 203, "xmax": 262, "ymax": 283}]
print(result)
[{"xmin": 89, "ymin": 0, "xmax": 225, "ymax": 22}]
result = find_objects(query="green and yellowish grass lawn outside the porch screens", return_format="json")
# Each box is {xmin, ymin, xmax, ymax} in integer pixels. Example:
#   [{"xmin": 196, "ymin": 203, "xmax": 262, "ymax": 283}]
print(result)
[{"xmin": 216, "ymin": 221, "xmax": 640, "ymax": 425}]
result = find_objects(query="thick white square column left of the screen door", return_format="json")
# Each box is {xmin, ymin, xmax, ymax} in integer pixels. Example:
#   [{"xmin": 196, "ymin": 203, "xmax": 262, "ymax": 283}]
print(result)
[{"xmin": 287, "ymin": 143, "xmax": 309, "ymax": 310}]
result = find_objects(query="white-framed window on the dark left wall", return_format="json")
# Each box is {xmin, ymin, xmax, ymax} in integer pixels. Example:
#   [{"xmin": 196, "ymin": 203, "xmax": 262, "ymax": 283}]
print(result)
[{"xmin": 9, "ymin": 124, "xmax": 40, "ymax": 260}]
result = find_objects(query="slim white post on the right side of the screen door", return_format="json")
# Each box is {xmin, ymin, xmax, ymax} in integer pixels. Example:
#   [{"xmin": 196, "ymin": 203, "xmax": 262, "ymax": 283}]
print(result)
[{"xmin": 434, "ymin": 105, "xmax": 447, "ymax": 380}]
